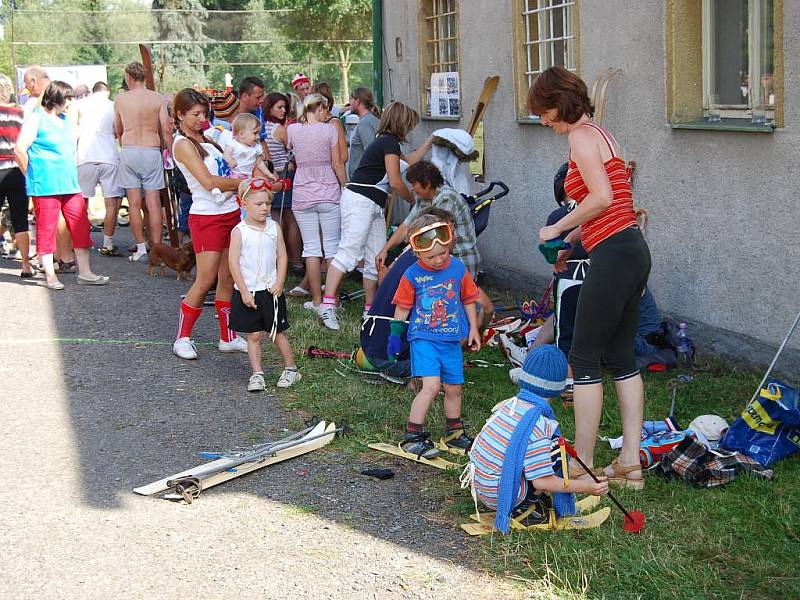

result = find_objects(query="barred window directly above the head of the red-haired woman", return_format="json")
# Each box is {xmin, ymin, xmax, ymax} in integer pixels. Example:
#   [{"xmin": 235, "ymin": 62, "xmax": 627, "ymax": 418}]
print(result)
[{"xmin": 520, "ymin": 0, "xmax": 578, "ymax": 121}]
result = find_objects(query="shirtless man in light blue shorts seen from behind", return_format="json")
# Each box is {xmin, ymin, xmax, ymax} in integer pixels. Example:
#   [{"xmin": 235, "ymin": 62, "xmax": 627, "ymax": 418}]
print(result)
[{"xmin": 114, "ymin": 61, "xmax": 172, "ymax": 262}]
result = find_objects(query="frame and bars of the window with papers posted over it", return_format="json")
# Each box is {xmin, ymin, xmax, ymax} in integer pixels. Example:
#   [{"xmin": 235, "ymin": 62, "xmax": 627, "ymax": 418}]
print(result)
[{"xmin": 420, "ymin": 0, "xmax": 463, "ymax": 121}]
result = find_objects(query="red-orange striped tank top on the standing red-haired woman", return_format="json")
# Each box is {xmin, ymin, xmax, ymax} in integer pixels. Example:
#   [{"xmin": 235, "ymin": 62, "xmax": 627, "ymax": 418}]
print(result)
[{"xmin": 564, "ymin": 123, "xmax": 636, "ymax": 252}]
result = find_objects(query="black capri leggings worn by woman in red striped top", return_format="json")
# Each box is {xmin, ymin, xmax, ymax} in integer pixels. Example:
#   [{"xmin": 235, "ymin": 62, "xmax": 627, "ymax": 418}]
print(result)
[{"xmin": 569, "ymin": 227, "xmax": 650, "ymax": 385}]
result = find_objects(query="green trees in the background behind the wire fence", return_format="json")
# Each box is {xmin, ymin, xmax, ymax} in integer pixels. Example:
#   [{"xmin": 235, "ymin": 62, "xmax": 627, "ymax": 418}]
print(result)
[{"xmin": 0, "ymin": 0, "xmax": 372, "ymax": 101}]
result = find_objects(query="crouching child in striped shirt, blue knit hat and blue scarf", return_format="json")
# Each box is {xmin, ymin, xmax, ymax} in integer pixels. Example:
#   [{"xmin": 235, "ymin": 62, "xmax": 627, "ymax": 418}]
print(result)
[{"xmin": 470, "ymin": 345, "xmax": 608, "ymax": 531}]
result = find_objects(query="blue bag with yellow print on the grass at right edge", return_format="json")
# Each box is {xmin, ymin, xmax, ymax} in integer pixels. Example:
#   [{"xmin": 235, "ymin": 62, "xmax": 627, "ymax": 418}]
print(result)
[{"xmin": 720, "ymin": 379, "xmax": 800, "ymax": 467}]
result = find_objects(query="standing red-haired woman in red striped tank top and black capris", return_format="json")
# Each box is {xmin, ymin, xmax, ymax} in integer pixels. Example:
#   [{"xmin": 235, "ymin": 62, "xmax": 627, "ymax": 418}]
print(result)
[{"xmin": 528, "ymin": 67, "xmax": 650, "ymax": 489}]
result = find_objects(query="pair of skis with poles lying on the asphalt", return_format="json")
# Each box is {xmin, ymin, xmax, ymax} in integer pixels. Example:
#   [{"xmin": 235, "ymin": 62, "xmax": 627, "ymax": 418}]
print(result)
[{"xmin": 133, "ymin": 421, "xmax": 341, "ymax": 504}]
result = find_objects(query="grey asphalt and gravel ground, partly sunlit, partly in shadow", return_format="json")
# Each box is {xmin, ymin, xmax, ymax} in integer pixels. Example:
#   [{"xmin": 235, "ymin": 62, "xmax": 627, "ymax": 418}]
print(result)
[{"xmin": 0, "ymin": 230, "xmax": 521, "ymax": 599}]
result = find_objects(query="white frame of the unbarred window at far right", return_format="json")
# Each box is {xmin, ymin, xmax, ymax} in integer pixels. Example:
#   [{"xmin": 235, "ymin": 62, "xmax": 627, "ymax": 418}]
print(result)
[{"xmin": 703, "ymin": 0, "xmax": 775, "ymax": 121}]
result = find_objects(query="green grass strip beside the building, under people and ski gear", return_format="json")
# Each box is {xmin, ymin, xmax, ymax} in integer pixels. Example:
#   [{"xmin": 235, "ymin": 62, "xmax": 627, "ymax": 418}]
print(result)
[{"xmin": 269, "ymin": 284, "xmax": 800, "ymax": 600}]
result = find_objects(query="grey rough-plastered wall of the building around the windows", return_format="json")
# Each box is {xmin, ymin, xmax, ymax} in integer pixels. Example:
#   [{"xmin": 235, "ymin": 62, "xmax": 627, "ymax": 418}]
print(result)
[{"xmin": 384, "ymin": 0, "xmax": 800, "ymax": 366}]
